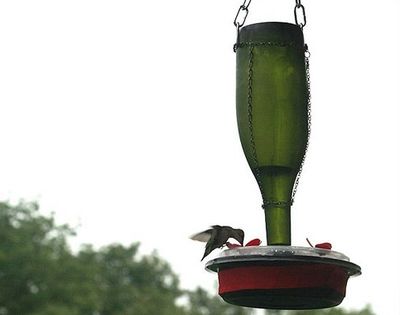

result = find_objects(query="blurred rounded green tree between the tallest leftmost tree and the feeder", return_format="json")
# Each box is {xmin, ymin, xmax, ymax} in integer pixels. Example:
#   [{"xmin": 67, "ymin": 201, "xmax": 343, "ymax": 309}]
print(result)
[{"xmin": 78, "ymin": 244, "xmax": 186, "ymax": 315}]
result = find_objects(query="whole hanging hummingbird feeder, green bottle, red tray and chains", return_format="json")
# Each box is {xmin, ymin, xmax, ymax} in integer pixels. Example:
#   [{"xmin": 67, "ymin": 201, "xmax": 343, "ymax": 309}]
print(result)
[{"xmin": 206, "ymin": 0, "xmax": 361, "ymax": 309}]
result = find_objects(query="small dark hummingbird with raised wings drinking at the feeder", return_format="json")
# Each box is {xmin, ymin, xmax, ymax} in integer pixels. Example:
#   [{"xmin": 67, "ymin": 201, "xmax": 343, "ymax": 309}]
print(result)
[{"xmin": 191, "ymin": 225, "xmax": 244, "ymax": 261}]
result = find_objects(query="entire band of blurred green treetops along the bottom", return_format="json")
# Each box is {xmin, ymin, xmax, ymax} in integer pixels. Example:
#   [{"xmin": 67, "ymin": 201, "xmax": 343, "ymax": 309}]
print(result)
[{"xmin": 0, "ymin": 202, "xmax": 374, "ymax": 315}]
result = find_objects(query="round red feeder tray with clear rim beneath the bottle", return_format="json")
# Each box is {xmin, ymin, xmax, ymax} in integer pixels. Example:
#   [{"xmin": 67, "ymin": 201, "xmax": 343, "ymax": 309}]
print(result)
[{"xmin": 206, "ymin": 246, "xmax": 361, "ymax": 310}]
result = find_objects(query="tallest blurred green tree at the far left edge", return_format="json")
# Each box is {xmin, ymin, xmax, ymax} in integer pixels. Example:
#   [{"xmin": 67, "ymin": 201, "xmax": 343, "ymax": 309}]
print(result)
[{"xmin": 0, "ymin": 203, "xmax": 79, "ymax": 314}]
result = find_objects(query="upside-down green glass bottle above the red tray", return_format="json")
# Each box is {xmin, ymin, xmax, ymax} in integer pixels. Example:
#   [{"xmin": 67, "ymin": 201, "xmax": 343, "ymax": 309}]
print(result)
[{"xmin": 236, "ymin": 22, "xmax": 309, "ymax": 245}]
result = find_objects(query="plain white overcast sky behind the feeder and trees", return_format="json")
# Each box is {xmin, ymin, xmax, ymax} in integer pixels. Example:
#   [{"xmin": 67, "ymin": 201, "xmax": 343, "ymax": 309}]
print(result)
[{"xmin": 0, "ymin": 0, "xmax": 400, "ymax": 315}]
